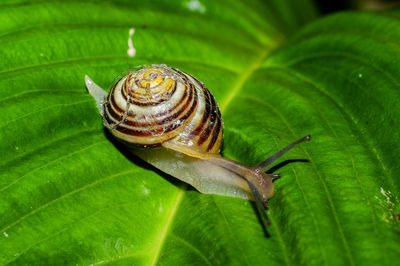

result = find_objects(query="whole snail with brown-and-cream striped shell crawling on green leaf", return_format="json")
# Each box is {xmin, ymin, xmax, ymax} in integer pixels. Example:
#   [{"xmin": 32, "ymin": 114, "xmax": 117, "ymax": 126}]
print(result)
[{"xmin": 85, "ymin": 65, "xmax": 310, "ymax": 231}]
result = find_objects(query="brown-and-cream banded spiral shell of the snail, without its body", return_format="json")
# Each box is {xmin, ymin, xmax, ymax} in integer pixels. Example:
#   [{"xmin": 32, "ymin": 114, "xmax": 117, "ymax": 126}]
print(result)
[{"xmin": 103, "ymin": 65, "xmax": 223, "ymax": 158}]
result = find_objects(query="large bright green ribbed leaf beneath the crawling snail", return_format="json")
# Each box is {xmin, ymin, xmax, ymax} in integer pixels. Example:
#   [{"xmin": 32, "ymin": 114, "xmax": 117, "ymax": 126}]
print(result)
[{"xmin": 0, "ymin": 0, "xmax": 400, "ymax": 265}]
